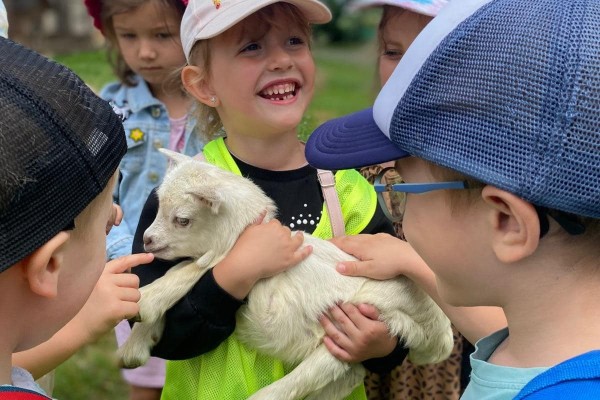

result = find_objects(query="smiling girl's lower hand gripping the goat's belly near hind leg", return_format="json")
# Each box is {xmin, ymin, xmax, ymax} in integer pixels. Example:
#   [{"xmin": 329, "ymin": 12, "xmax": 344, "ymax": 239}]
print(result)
[{"xmin": 319, "ymin": 303, "xmax": 398, "ymax": 363}]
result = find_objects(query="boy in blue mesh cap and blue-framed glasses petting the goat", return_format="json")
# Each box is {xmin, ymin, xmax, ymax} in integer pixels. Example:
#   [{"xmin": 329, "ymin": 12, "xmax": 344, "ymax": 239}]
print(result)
[{"xmin": 307, "ymin": 0, "xmax": 600, "ymax": 400}]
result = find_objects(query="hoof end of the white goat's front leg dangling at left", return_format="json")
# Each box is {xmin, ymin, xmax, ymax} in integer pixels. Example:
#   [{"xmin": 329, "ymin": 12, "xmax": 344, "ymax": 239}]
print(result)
[{"xmin": 117, "ymin": 316, "xmax": 165, "ymax": 368}]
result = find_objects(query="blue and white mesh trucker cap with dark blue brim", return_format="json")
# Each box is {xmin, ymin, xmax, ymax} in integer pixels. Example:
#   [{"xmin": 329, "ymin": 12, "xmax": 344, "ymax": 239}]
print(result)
[{"xmin": 306, "ymin": 0, "xmax": 600, "ymax": 218}]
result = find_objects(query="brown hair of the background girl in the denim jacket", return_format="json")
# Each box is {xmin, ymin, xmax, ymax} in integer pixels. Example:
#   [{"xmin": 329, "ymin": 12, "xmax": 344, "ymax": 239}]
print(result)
[{"xmin": 101, "ymin": 0, "xmax": 185, "ymax": 86}]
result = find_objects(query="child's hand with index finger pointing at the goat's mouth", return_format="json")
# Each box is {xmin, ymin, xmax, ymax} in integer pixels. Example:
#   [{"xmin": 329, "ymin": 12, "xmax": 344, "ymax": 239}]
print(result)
[{"xmin": 72, "ymin": 253, "xmax": 154, "ymax": 343}]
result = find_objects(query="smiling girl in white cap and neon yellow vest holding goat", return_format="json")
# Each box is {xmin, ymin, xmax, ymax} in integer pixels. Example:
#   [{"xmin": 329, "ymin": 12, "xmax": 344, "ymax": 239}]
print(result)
[{"xmin": 134, "ymin": 0, "xmax": 406, "ymax": 400}]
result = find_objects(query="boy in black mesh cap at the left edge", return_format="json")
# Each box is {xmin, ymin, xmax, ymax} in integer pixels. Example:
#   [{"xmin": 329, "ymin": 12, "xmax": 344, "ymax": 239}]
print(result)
[{"xmin": 0, "ymin": 38, "xmax": 138, "ymax": 399}]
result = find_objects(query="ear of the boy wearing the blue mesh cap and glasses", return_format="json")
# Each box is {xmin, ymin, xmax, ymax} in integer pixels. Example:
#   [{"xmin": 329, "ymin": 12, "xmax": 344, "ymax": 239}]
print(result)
[{"xmin": 481, "ymin": 186, "xmax": 540, "ymax": 263}]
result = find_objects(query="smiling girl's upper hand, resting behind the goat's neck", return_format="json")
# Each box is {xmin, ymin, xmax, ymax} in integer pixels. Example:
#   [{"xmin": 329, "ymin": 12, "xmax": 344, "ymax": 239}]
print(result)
[{"xmin": 213, "ymin": 215, "xmax": 312, "ymax": 299}]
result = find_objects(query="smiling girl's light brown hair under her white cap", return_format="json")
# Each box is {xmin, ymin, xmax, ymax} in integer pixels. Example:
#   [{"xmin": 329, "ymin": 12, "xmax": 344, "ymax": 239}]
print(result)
[{"xmin": 189, "ymin": 2, "xmax": 311, "ymax": 141}]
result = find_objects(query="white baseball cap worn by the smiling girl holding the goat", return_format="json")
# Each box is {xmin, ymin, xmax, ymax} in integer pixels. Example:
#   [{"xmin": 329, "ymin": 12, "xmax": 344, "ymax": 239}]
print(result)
[{"xmin": 181, "ymin": 0, "xmax": 331, "ymax": 61}]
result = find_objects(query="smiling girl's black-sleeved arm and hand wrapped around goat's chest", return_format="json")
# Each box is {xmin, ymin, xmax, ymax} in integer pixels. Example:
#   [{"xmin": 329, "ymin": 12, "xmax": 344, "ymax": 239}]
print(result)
[{"xmin": 133, "ymin": 192, "xmax": 310, "ymax": 360}]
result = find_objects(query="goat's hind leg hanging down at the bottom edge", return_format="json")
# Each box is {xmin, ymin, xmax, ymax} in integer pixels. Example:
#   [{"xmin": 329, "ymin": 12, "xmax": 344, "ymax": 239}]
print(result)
[{"xmin": 248, "ymin": 344, "xmax": 364, "ymax": 400}]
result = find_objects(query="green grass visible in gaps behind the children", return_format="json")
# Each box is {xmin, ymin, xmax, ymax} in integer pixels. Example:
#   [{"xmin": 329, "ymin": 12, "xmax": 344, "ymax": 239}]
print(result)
[{"xmin": 54, "ymin": 45, "xmax": 375, "ymax": 400}]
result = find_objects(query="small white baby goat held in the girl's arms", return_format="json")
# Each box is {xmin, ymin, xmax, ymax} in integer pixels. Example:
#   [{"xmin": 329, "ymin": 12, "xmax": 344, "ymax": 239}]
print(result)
[{"xmin": 119, "ymin": 150, "xmax": 453, "ymax": 400}]
